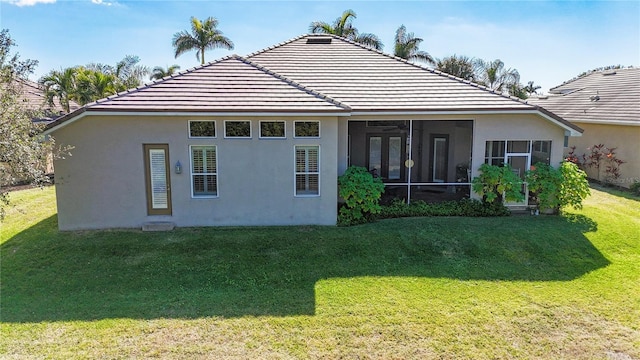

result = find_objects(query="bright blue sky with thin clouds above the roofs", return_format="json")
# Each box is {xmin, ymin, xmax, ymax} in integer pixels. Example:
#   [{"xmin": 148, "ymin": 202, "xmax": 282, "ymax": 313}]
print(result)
[{"xmin": 0, "ymin": 0, "xmax": 640, "ymax": 92}]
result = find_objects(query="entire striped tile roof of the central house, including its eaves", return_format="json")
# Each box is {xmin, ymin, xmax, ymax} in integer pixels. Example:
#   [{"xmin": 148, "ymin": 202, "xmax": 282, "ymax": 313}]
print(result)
[{"xmin": 49, "ymin": 34, "xmax": 582, "ymax": 133}]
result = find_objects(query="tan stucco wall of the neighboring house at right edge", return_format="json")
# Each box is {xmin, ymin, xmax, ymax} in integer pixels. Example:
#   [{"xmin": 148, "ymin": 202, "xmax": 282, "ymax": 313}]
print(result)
[{"xmin": 569, "ymin": 123, "xmax": 640, "ymax": 188}]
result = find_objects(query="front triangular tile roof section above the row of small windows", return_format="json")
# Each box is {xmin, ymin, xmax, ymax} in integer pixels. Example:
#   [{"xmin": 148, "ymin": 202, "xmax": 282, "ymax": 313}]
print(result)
[{"xmin": 88, "ymin": 55, "xmax": 348, "ymax": 112}]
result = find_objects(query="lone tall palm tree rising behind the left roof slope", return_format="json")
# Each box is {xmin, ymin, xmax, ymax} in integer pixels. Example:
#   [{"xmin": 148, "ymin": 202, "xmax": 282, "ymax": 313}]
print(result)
[{"xmin": 173, "ymin": 16, "xmax": 233, "ymax": 65}]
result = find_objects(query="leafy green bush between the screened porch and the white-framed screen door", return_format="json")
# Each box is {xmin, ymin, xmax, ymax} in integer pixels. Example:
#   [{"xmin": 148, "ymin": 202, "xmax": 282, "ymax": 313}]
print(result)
[{"xmin": 471, "ymin": 164, "xmax": 524, "ymax": 204}]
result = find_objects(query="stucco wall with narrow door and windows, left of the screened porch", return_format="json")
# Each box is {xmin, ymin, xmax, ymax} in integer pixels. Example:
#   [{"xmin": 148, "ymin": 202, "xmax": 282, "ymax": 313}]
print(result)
[{"xmin": 53, "ymin": 115, "xmax": 338, "ymax": 230}]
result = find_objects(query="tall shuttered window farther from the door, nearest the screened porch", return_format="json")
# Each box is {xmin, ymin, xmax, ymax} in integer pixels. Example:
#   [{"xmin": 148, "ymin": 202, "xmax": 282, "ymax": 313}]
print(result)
[{"xmin": 295, "ymin": 146, "xmax": 320, "ymax": 196}]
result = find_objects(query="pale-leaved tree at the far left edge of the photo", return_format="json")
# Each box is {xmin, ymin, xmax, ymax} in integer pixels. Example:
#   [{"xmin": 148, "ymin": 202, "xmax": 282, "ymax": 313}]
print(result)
[{"xmin": 0, "ymin": 30, "xmax": 62, "ymax": 219}]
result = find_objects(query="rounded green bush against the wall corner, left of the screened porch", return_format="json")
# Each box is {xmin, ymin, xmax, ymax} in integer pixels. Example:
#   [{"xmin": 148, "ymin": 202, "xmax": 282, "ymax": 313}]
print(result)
[{"xmin": 338, "ymin": 166, "xmax": 384, "ymax": 225}]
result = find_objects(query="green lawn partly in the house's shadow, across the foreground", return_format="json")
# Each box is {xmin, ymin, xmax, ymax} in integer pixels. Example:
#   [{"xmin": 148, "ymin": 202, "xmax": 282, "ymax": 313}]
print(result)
[{"xmin": 0, "ymin": 184, "xmax": 640, "ymax": 359}]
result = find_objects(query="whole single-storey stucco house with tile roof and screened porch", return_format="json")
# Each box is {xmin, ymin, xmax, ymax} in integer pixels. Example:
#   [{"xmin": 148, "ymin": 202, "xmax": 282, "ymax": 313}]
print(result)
[{"xmin": 46, "ymin": 35, "xmax": 581, "ymax": 230}]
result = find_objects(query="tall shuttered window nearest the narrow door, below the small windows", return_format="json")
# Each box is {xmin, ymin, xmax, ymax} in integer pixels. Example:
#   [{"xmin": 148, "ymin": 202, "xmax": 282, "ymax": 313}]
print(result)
[{"xmin": 191, "ymin": 146, "xmax": 218, "ymax": 197}]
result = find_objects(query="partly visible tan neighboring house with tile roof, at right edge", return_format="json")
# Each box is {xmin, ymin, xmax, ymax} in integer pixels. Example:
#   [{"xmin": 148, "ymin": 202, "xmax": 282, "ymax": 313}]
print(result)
[{"xmin": 529, "ymin": 68, "xmax": 640, "ymax": 188}]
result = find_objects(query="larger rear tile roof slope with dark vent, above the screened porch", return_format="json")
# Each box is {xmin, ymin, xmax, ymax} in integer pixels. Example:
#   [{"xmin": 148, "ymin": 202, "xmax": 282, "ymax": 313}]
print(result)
[{"xmin": 247, "ymin": 35, "xmax": 535, "ymax": 111}]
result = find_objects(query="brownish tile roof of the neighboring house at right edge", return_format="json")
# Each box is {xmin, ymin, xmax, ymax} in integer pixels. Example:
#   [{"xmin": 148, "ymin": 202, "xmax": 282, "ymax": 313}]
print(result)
[{"xmin": 530, "ymin": 68, "xmax": 640, "ymax": 126}]
